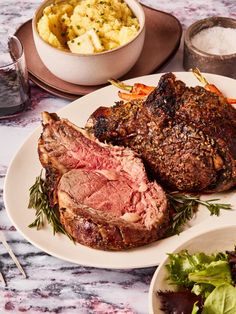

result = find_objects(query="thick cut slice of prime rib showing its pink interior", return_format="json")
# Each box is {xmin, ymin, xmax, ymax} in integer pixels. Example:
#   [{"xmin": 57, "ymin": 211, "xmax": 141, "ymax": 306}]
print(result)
[{"xmin": 38, "ymin": 112, "xmax": 169, "ymax": 250}]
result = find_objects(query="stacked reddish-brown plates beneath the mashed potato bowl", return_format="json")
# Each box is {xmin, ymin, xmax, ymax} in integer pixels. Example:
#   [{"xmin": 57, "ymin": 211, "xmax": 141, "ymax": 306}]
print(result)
[{"xmin": 15, "ymin": 6, "xmax": 182, "ymax": 99}]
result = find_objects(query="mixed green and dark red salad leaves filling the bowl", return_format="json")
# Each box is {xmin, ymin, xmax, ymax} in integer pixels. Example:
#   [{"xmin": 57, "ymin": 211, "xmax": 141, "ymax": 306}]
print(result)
[{"xmin": 159, "ymin": 250, "xmax": 236, "ymax": 314}]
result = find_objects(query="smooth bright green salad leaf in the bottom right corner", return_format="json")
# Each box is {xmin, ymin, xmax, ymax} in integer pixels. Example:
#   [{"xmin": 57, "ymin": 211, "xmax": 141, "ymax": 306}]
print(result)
[{"xmin": 202, "ymin": 284, "xmax": 236, "ymax": 314}]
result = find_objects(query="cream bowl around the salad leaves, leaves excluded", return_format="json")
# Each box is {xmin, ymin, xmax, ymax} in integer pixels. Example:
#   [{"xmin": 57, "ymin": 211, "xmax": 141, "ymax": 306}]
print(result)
[{"xmin": 149, "ymin": 223, "xmax": 236, "ymax": 314}]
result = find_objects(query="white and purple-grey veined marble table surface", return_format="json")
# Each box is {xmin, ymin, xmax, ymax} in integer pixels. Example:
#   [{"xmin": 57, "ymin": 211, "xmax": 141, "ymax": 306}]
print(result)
[{"xmin": 0, "ymin": 0, "xmax": 236, "ymax": 314}]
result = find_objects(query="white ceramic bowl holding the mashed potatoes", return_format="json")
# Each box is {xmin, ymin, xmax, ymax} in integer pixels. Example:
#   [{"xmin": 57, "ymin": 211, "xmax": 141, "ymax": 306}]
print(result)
[{"xmin": 32, "ymin": 0, "xmax": 145, "ymax": 85}]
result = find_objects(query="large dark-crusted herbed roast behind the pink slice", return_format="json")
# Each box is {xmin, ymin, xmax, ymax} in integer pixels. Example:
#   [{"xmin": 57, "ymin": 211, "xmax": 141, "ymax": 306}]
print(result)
[{"xmin": 86, "ymin": 73, "xmax": 236, "ymax": 192}]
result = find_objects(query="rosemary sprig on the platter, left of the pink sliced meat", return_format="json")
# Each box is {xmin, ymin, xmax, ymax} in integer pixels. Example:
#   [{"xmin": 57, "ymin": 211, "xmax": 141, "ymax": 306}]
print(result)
[{"xmin": 28, "ymin": 171, "xmax": 72, "ymax": 239}]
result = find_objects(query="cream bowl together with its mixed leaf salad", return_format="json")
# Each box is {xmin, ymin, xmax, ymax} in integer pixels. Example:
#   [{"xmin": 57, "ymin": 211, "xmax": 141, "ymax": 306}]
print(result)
[{"xmin": 149, "ymin": 223, "xmax": 236, "ymax": 314}]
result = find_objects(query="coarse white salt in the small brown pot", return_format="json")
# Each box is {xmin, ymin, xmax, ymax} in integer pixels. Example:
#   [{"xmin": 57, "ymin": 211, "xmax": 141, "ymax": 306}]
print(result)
[{"xmin": 192, "ymin": 26, "xmax": 236, "ymax": 55}]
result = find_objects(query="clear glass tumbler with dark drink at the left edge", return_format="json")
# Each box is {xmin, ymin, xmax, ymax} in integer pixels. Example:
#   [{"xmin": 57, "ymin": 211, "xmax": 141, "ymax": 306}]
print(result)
[{"xmin": 0, "ymin": 36, "xmax": 30, "ymax": 119}]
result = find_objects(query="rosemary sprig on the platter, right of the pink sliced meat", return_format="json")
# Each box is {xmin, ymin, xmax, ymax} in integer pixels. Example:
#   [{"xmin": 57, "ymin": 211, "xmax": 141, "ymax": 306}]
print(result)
[{"xmin": 167, "ymin": 192, "xmax": 232, "ymax": 234}]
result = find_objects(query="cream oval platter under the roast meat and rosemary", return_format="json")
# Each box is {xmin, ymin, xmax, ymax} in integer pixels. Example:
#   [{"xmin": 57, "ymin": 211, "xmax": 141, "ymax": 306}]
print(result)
[{"xmin": 3, "ymin": 72, "xmax": 236, "ymax": 269}]
